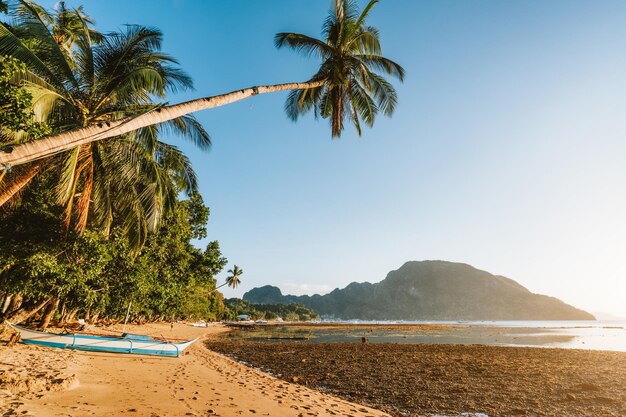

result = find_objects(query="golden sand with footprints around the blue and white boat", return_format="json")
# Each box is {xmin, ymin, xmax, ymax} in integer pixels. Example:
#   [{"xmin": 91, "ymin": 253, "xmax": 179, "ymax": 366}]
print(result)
[{"xmin": 0, "ymin": 324, "xmax": 387, "ymax": 417}]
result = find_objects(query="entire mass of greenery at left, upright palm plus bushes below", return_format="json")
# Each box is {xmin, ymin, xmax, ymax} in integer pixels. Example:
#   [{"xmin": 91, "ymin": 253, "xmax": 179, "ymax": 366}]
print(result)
[{"xmin": 0, "ymin": 1, "xmax": 232, "ymax": 328}]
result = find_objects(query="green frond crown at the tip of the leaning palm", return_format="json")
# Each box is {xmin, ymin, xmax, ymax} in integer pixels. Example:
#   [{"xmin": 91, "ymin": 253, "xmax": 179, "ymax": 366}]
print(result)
[{"xmin": 275, "ymin": 0, "xmax": 404, "ymax": 137}]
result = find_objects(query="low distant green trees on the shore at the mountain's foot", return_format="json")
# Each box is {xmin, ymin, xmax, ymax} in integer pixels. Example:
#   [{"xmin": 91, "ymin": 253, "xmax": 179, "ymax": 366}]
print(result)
[{"xmin": 224, "ymin": 298, "xmax": 319, "ymax": 321}]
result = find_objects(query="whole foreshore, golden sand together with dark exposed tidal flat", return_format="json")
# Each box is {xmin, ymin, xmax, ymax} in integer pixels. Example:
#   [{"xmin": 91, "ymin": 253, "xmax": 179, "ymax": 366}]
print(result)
[{"xmin": 0, "ymin": 323, "xmax": 626, "ymax": 417}]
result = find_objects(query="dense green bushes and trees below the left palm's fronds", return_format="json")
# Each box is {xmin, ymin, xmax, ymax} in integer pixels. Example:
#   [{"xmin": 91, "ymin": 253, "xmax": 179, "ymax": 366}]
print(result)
[{"xmin": 0, "ymin": 177, "xmax": 232, "ymax": 327}]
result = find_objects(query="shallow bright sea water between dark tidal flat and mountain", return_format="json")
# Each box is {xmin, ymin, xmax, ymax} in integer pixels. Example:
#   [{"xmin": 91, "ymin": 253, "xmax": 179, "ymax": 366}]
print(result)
[{"xmin": 235, "ymin": 320, "xmax": 626, "ymax": 352}]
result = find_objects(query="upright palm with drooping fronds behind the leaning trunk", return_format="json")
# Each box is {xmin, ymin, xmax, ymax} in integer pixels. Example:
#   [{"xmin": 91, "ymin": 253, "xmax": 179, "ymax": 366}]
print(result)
[{"xmin": 0, "ymin": 1, "xmax": 210, "ymax": 247}]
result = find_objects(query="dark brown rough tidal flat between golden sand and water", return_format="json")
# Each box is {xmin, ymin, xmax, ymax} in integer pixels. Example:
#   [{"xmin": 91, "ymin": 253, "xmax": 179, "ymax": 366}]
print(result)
[{"xmin": 207, "ymin": 339, "xmax": 626, "ymax": 416}]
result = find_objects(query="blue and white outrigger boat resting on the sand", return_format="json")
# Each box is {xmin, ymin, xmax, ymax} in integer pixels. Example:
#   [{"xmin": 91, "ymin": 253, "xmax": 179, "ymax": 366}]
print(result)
[{"xmin": 7, "ymin": 322, "xmax": 198, "ymax": 357}]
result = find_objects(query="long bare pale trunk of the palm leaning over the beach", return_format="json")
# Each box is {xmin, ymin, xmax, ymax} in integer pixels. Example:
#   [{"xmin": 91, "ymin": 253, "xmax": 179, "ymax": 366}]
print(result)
[{"xmin": 0, "ymin": 81, "xmax": 324, "ymax": 166}]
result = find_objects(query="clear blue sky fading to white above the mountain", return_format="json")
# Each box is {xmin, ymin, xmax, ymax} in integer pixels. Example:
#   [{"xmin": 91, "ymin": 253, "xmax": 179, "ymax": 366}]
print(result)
[{"xmin": 41, "ymin": 0, "xmax": 626, "ymax": 316}]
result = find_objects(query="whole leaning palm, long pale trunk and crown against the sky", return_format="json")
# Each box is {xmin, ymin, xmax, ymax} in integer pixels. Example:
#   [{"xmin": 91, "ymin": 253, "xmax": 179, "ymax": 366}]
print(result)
[{"xmin": 0, "ymin": 0, "xmax": 404, "ymax": 166}]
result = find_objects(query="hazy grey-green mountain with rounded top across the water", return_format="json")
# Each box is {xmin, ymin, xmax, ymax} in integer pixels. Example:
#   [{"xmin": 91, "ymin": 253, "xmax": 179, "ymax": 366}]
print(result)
[{"xmin": 243, "ymin": 261, "xmax": 594, "ymax": 320}]
